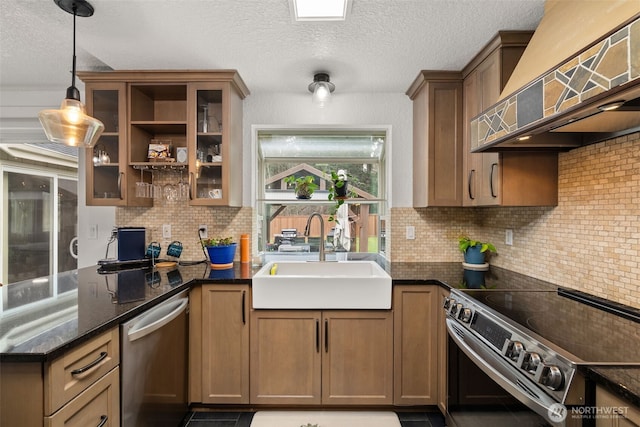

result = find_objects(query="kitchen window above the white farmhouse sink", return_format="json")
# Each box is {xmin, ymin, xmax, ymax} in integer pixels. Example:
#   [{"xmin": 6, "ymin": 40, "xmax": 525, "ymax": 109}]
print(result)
[{"xmin": 256, "ymin": 129, "xmax": 387, "ymax": 255}]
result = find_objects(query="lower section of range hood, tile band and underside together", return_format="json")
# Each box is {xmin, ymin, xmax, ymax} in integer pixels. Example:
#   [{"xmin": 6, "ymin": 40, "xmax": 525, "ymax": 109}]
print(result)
[{"xmin": 471, "ymin": 9, "xmax": 640, "ymax": 152}]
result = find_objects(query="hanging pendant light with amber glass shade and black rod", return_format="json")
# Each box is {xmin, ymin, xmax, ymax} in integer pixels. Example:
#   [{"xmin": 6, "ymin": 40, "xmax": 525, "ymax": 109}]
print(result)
[{"xmin": 38, "ymin": 0, "xmax": 104, "ymax": 147}]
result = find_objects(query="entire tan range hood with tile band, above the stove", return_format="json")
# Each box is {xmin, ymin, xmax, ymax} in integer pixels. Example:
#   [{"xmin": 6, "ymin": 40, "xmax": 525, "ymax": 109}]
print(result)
[{"xmin": 471, "ymin": 0, "xmax": 640, "ymax": 152}]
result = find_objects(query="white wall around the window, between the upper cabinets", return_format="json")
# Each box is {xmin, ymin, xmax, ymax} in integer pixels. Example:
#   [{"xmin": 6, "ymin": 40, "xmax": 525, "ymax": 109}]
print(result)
[{"xmin": 242, "ymin": 92, "xmax": 413, "ymax": 207}]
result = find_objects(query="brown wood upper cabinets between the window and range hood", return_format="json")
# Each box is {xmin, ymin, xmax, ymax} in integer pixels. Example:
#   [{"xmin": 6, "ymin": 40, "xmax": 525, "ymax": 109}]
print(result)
[{"xmin": 407, "ymin": 31, "xmax": 558, "ymax": 207}]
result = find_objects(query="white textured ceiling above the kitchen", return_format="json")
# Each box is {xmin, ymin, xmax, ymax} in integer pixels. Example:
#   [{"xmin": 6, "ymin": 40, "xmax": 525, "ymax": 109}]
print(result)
[{"xmin": 0, "ymin": 0, "xmax": 544, "ymax": 93}]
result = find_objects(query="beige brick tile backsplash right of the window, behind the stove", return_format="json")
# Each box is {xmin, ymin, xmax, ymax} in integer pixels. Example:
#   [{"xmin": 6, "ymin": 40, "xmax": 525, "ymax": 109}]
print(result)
[{"xmin": 390, "ymin": 133, "xmax": 640, "ymax": 308}]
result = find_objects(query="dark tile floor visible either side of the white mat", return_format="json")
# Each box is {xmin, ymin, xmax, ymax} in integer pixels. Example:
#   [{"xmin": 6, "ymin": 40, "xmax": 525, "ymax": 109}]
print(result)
[{"xmin": 183, "ymin": 412, "xmax": 445, "ymax": 427}]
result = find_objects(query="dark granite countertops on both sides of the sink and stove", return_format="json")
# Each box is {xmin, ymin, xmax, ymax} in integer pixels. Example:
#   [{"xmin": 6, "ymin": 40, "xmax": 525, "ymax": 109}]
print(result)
[{"xmin": 0, "ymin": 262, "xmax": 640, "ymax": 406}]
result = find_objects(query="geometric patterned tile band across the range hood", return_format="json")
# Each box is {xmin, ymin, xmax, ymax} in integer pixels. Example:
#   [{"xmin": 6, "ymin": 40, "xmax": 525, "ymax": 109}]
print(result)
[{"xmin": 471, "ymin": 19, "xmax": 640, "ymax": 150}]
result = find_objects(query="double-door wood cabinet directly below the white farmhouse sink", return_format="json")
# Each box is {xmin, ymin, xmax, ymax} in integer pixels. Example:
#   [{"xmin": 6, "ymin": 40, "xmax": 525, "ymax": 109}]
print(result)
[{"xmin": 251, "ymin": 310, "xmax": 393, "ymax": 405}]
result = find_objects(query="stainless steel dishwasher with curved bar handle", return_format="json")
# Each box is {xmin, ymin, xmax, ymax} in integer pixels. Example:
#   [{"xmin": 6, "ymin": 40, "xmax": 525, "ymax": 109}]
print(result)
[{"xmin": 120, "ymin": 292, "xmax": 189, "ymax": 427}]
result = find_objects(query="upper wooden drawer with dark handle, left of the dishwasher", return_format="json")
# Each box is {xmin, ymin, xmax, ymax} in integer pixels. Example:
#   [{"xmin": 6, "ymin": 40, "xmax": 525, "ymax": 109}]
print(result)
[{"xmin": 44, "ymin": 328, "xmax": 120, "ymax": 415}]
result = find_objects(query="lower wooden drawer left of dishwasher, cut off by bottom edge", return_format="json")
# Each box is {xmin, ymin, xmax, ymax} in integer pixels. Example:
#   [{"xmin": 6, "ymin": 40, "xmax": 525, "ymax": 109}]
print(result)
[{"xmin": 44, "ymin": 368, "xmax": 120, "ymax": 427}]
